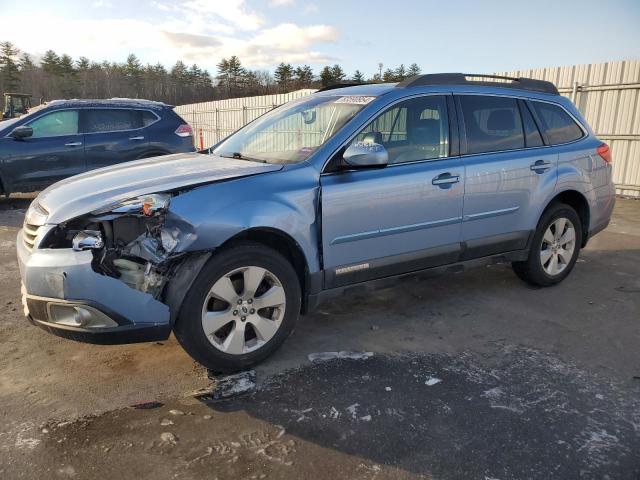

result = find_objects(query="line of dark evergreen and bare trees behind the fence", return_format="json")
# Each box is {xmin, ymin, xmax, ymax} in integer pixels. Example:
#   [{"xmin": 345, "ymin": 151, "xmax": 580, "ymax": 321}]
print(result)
[{"xmin": 0, "ymin": 42, "xmax": 420, "ymax": 105}]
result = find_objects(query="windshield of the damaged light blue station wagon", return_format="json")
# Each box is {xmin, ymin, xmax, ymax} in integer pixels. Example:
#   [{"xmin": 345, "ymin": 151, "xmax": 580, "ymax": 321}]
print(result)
[{"xmin": 213, "ymin": 95, "xmax": 375, "ymax": 163}]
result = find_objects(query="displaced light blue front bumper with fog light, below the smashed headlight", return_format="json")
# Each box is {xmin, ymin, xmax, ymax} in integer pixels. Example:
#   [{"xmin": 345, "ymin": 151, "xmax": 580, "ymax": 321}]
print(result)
[{"xmin": 16, "ymin": 230, "xmax": 171, "ymax": 344}]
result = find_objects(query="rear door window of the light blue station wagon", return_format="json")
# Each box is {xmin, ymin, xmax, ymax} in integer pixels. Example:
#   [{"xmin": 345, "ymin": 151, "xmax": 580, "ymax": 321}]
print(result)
[{"xmin": 458, "ymin": 95, "xmax": 524, "ymax": 153}]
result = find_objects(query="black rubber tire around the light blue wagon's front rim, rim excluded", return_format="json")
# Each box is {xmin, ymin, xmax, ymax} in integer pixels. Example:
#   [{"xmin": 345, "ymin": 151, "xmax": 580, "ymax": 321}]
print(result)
[{"xmin": 174, "ymin": 242, "xmax": 301, "ymax": 373}]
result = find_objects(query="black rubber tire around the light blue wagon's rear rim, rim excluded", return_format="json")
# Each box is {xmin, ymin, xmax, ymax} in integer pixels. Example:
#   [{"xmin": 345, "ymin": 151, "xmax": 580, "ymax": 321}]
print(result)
[{"xmin": 511, "ymin": 203, "xmax": 582, "ymax": 287}]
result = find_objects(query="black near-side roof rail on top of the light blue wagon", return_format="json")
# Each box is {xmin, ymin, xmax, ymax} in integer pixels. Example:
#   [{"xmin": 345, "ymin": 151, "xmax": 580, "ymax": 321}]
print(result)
[{"xmin": 396, "ymin": 73, "xmax": 560, "ymax": 95}]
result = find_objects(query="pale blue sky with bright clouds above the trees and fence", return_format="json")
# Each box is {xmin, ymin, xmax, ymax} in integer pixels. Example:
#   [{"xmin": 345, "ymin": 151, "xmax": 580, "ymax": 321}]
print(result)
[{"xmin": 0, "ymin": 0, "xmax": 640, "ymax": 75}]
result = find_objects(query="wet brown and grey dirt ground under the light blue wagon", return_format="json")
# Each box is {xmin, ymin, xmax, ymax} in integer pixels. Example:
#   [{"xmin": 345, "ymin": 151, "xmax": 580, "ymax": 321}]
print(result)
[{"xmin": 0, "ymin": 193, "xmax": 640, "ymax": 480}]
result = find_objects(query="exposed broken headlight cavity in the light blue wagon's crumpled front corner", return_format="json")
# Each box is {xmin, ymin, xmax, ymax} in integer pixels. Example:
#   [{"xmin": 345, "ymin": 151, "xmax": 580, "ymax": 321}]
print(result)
[{"xmin": 45, "ymin": 194, "xmax": 191, "ymax": 298}]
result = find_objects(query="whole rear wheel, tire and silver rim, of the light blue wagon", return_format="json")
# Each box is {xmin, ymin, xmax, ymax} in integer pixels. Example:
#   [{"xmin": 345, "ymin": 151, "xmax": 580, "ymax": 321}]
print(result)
[{"xmin": 512, "ymin": 203, "xmax": 582, "ymax": 287}]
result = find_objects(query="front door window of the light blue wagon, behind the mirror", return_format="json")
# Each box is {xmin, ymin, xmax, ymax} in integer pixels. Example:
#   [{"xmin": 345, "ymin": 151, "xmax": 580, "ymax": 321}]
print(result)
[{"xmin": 350, "ymin": 95, "xmax": 449, "ymax": 164}]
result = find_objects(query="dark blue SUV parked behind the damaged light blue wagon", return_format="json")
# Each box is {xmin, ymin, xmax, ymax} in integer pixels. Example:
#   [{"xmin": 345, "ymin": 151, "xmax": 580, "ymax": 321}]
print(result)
[{"xmin": 0, "ymin": 99, "xmax": 195, "ymax": 195}]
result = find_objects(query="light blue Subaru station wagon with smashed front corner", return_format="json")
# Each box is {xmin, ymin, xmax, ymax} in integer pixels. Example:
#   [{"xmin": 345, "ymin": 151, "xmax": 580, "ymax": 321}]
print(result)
[{"xmin": 18, "ymin": 74, "xmax": 615, "ymax": 371}]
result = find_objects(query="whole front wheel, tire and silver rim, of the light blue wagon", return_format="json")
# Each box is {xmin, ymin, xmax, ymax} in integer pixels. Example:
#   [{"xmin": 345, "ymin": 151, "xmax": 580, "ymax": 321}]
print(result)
[{"xmin": 174, "ymin": 243, "xmax": 301, "ymax": 372}]
